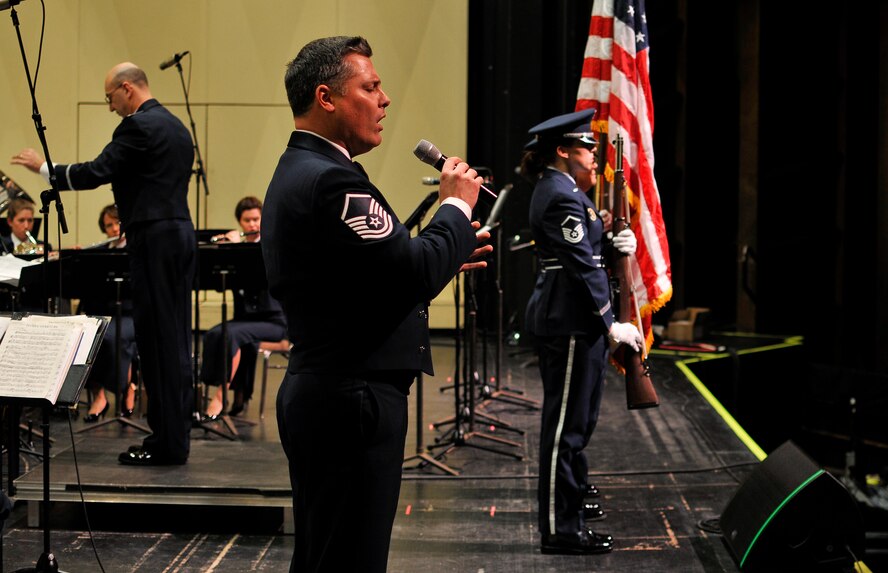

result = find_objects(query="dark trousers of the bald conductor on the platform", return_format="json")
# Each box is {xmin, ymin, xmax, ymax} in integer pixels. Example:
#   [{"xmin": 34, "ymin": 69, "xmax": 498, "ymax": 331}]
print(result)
[{"xmin": 126, "ymin": 219, "xmax": 196, "ymax": 463}]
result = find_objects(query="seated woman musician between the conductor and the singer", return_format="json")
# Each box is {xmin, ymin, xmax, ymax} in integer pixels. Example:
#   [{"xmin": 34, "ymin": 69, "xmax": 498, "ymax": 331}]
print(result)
[{"xmin": 200, "ymin": 197, "xmax": 287, "ymax": 421}]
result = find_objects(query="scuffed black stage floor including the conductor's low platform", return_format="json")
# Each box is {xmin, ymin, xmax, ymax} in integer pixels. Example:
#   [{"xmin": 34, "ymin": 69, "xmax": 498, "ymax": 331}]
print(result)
[{"xmin": 0, "ymin": 336, "xmax": 758, "ymax": 573}]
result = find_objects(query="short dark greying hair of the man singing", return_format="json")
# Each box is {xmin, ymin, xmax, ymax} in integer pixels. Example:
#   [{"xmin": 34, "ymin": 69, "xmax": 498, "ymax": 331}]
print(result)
[{"xmin": 284, "ymin": 36, "xmax": 373, "ymax": 117}]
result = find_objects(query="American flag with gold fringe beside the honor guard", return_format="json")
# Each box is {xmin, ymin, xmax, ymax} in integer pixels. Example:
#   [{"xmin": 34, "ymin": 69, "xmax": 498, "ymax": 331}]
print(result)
[{"xmin": 576, "ymin": 0, "xmax": 672, "ymax": 348}]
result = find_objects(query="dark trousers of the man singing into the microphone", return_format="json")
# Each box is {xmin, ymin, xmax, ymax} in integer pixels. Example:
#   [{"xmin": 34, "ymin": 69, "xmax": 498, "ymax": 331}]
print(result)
[{"xmin": 277, "ymin": 370, "xmax": 409, "ymax": 573}]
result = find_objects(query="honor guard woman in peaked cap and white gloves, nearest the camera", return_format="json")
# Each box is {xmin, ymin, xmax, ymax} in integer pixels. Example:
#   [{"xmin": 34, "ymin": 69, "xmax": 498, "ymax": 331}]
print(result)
[{"xmin": 521, "ymin": 109, "xmax": 642, "ymax": 554}]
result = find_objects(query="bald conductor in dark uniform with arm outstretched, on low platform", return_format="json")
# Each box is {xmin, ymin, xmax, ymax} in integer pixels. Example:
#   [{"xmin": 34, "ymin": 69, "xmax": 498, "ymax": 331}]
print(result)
[{"xmin": 12, "ymin": 62, "xmax": 196, "ymax": 465}]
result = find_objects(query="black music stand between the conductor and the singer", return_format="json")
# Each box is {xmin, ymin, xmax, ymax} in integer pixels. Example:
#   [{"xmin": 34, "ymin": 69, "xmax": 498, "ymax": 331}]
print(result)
[{"xmin": 194, "ymin": 243, "xmax": 268, "ymax": 440}]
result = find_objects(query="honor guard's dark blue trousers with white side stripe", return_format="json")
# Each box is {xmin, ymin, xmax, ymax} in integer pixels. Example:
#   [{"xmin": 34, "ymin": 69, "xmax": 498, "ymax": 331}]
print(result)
[{"xmin": 537, "ymin": 335, "xmax": 608, "ymax": 535}]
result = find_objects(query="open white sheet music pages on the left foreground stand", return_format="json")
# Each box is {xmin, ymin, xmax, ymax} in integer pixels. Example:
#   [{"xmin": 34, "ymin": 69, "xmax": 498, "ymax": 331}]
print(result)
[{"xmin": 0, "ymin": 320, "xmax": 83, "ymax": 404}]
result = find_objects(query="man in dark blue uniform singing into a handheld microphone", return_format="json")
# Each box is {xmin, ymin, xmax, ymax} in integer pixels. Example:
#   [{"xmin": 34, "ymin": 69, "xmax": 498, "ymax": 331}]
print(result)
[{"xmin": 261, "ymin": 37, "xmax": 489, "ymax": 573}]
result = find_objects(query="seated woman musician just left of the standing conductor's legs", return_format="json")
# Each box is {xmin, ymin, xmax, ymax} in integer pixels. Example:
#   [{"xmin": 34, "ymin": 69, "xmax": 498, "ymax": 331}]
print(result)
[{"xmin": 79, "ymin": 204, "xmax": 136, "ymax": 423}]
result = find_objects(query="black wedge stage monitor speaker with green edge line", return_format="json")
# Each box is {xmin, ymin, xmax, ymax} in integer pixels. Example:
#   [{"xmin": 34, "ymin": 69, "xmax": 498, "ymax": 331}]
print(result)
[{"xmin": 720, "ymin": 442, "xmax": 865, "ymax": 572}]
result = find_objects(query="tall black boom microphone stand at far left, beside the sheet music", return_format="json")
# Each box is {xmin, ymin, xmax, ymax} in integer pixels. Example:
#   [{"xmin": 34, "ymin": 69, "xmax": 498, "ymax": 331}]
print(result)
[{"xmin": 8, "ymin": 5, "xmax": 68, "ymax": 573}]
